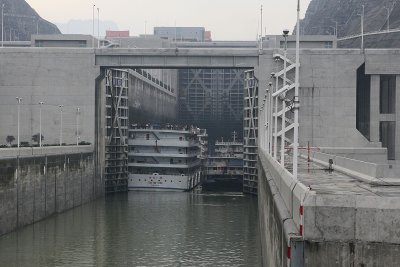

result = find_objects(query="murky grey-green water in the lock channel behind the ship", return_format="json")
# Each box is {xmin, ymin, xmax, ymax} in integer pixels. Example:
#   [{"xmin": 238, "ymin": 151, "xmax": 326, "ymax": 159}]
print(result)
[{"xmin": 0, "ymin": 192, "xmax": 260, "ymax": 266}]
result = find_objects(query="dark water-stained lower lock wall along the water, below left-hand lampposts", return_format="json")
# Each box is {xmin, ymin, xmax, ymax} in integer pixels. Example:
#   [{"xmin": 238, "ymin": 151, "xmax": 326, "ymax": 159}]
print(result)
[{"xmin": 0, "ymin": 147, "xmax": 104, "ymax": 238}]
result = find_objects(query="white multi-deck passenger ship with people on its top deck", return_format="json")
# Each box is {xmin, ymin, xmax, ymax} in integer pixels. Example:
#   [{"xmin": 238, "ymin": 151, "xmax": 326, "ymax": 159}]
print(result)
[{"xmin": 128, "ymin": 124, "xmax": 201, "ymax": 191}]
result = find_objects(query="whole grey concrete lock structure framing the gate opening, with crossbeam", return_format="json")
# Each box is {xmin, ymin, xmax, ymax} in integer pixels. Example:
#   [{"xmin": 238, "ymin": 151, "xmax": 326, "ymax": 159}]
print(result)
[{"xmin": 0, "ymin": 34, "xmax": 400, "ymax": 266}]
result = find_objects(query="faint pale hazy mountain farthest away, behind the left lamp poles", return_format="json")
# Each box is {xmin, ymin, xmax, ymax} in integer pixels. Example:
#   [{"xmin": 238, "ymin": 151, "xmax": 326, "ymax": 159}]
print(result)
[{"xmin": 57, "ymin": 20, "xmax": 118, "ymax": 36}]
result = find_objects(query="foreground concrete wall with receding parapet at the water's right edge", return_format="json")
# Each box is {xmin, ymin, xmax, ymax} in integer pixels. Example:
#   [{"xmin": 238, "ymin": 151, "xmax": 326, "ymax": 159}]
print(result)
[{"xmin": 258, "ymin": 150, "xmax": 400, "ymax": 267}]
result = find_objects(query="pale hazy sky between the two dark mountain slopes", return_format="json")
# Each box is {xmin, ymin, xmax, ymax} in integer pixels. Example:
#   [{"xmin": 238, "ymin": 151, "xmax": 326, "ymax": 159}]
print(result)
[{"xmin": 26, "ymin": 0, "xmax": 311, "ymax": 40}]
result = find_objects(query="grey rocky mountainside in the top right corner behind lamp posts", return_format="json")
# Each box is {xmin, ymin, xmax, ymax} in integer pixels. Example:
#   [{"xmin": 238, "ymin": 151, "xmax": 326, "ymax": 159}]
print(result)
[{"xmin": 300, "ymin": 0, "xmax": 400, "ymax": 48}]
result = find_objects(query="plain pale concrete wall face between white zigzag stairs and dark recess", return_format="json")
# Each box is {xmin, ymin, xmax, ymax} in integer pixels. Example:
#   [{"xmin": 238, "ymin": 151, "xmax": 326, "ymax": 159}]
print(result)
[{"xmin": 256, "ymin": 49, "xmax": 371, "ymax": 150}]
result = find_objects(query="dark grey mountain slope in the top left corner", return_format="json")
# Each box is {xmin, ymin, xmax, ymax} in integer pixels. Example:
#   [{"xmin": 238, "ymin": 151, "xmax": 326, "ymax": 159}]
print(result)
[{"xmin": 0, "ymin": 0, "xmax": 60, "ymax": 41}]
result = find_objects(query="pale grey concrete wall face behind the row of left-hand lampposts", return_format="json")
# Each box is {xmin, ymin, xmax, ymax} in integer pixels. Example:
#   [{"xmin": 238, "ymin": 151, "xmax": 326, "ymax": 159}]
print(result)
[{"xmin": 0, "ymin": 48, "xmax": 98, "ymax": 148}]
